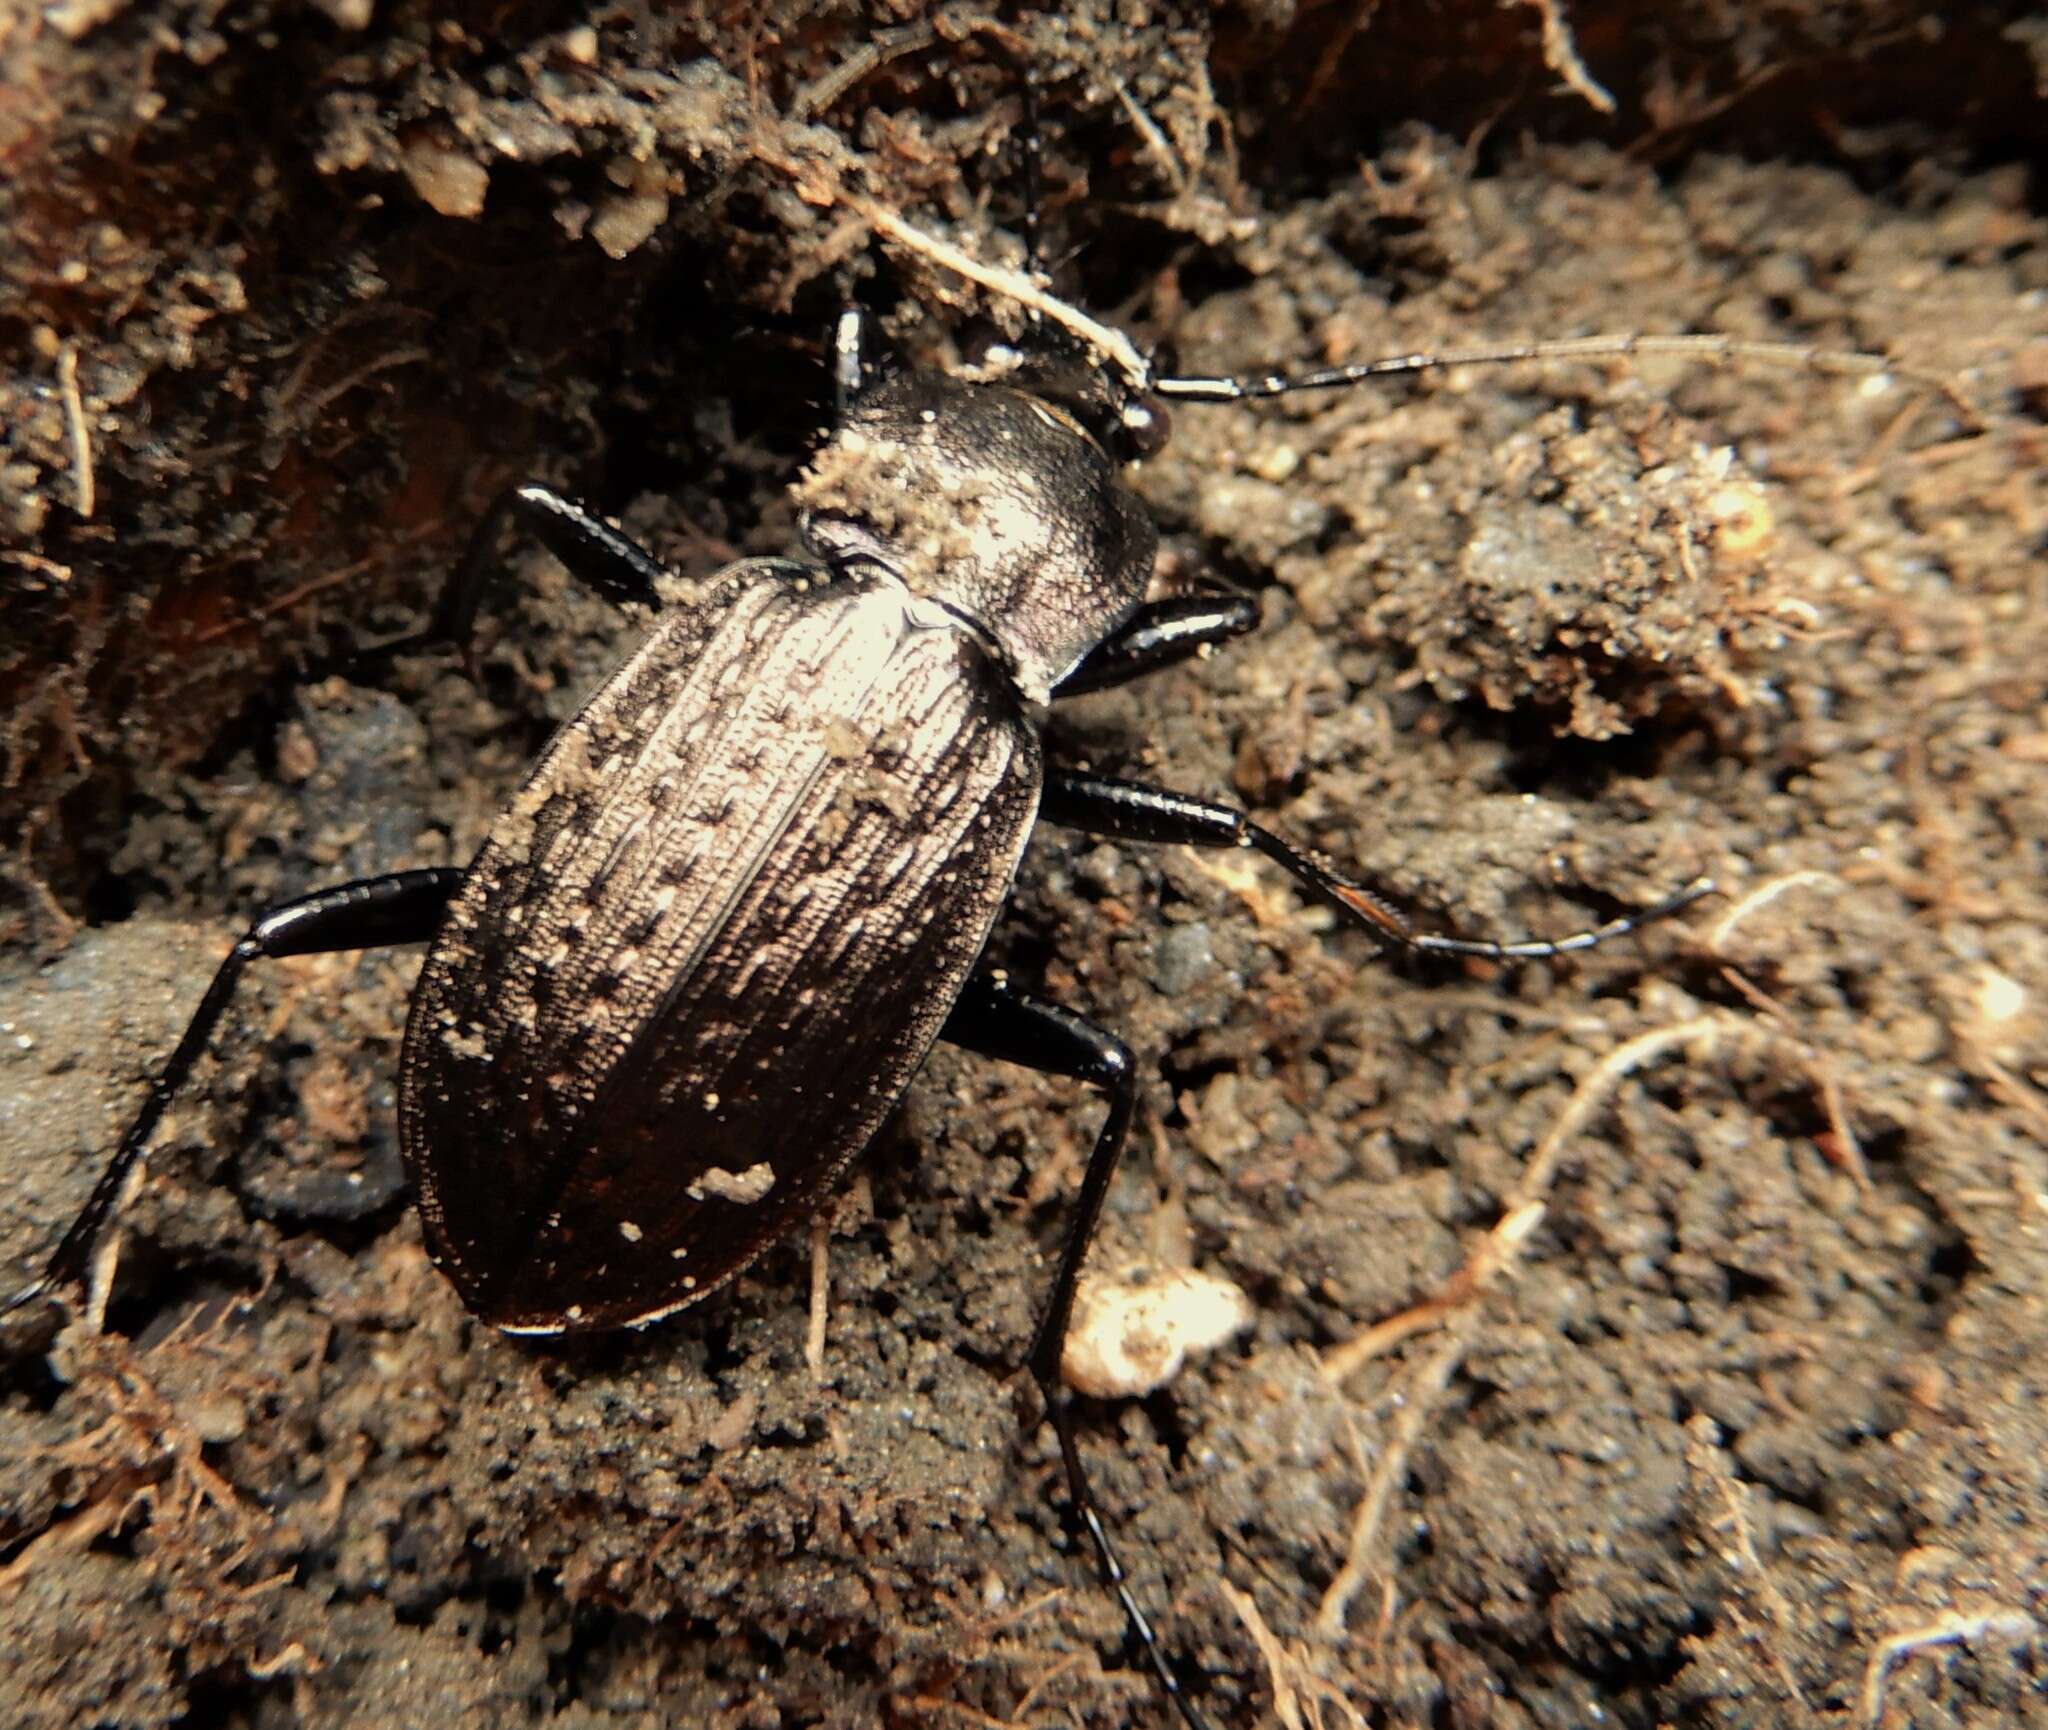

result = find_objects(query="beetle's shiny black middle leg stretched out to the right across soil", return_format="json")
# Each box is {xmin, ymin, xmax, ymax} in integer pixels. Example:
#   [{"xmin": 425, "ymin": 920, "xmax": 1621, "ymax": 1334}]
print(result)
[{"xmin": 1038, "ymin": 772, "xmax": 1714, "ymax": 960}]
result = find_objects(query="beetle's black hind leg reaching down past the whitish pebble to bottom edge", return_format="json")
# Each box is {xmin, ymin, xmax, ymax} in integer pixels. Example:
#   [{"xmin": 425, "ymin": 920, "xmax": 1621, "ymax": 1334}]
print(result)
[{"xmin": 940, "ymin": 972, "xmax": 1210, "ymax": 1730}]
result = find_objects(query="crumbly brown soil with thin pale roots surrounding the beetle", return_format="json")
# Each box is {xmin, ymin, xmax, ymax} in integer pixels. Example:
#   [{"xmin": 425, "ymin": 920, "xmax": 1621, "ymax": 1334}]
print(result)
[{"xmin": 0, "ymin": 0, "xmax": 2048, "ymax": 1730}]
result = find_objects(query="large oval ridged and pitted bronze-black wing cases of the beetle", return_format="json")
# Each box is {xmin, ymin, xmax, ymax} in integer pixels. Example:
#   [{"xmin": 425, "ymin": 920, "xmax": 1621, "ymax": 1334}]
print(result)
[{"xmin": 411, "ymin": 565, "xmax": 1038, "ymax": 1333}]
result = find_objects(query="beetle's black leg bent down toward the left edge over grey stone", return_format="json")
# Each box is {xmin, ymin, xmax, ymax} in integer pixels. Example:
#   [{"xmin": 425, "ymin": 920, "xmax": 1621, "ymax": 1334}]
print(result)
[{"xmin": 0, "ymin": 866, "xmax": 465, "ymax": 1312}]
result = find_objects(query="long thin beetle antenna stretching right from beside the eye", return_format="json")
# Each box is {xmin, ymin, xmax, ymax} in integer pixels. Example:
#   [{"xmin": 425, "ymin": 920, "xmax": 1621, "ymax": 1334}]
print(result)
[{"xmin": 1145, "ymin": 334, "xmax": 1980, "ymax": 424}]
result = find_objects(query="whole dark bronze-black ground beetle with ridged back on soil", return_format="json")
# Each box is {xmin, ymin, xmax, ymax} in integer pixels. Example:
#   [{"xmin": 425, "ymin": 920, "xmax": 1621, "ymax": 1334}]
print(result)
[{"xmin": 16, "ymin": 236, "xmax": 1731, "ymax": 1730}]
